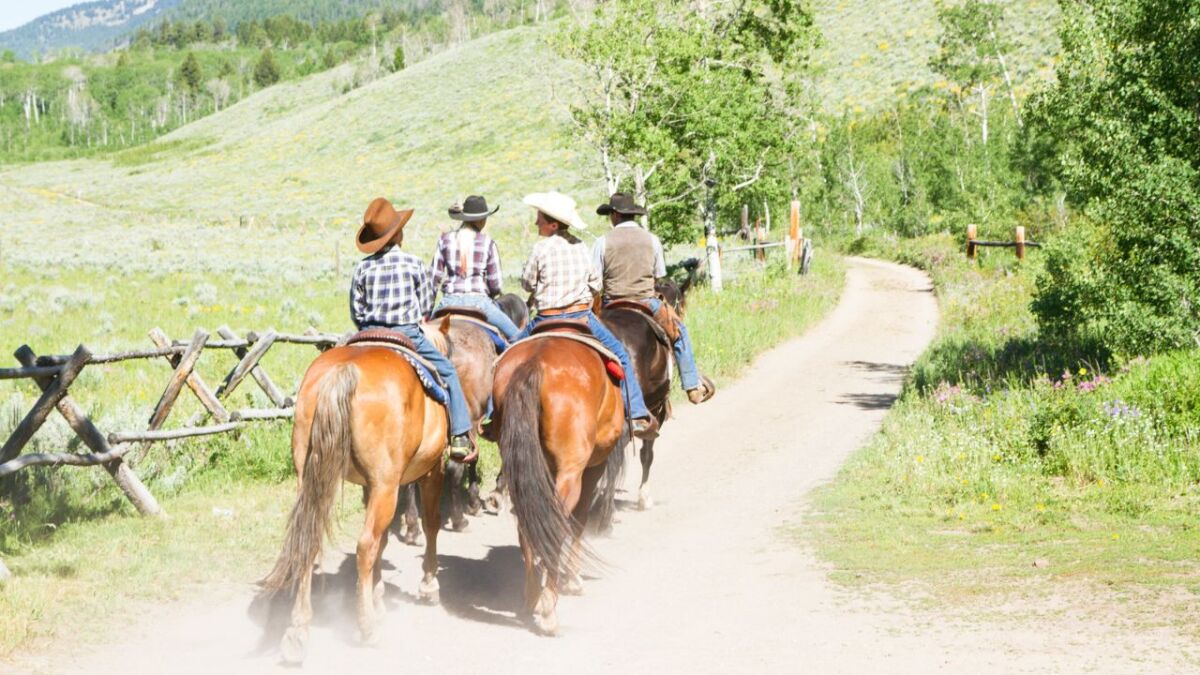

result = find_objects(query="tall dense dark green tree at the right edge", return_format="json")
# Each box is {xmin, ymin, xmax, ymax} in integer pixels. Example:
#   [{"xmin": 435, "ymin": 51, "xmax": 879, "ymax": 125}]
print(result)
[{"xmin": 1033, "ymin": 0, "xmax": 1200, "ymax": 354}]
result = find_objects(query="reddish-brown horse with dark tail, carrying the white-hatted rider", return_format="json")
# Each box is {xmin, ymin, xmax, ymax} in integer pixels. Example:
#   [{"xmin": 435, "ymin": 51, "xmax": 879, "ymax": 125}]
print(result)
[{"xmin": 487, "ymin": 336, "xmax": 625, "ymax": 634}]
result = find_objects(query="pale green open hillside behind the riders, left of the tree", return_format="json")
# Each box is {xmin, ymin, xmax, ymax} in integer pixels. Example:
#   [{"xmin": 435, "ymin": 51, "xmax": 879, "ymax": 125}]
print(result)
[{"xmin": 0, "ymin": 29, "xmax": 592, "ymax": 277}]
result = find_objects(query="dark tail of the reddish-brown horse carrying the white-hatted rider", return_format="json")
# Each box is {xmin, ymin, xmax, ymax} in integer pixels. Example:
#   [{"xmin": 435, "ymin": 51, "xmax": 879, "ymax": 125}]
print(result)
[{"xmin": 499, "ymin": 360, "xmax": 574, "ymax": 584}]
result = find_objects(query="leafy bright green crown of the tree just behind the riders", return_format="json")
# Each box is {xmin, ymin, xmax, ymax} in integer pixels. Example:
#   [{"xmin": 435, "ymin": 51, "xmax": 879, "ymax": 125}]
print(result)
[{"xmin": 556, "ymin": 0, "xmax": 816, "ymax": 243}]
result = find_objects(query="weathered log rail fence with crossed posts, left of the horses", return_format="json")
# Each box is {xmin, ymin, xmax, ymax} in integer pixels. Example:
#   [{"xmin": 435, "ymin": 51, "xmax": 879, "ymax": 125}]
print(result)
[{"xmin": 0, "ymin": 327, "xmax": 341, "ymax": 515}]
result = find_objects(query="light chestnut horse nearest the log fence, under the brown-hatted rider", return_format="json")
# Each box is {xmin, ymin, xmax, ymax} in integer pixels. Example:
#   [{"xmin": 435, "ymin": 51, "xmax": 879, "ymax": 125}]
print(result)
[{"xmin": 262, "ymin": 330, "xmax": 448, "ymax": 663}]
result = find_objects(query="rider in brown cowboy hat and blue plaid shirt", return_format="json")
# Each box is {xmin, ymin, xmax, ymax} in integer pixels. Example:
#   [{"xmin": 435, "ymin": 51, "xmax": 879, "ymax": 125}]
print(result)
[{"xmin": 350, "ymin": 197, "xmax": 470, "ymax": 459}]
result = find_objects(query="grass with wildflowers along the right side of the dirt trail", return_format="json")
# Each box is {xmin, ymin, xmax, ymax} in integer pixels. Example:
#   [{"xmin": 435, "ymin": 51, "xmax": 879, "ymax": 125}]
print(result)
[{"xmin": 794, "ymin": 230, "xmax": 1200, "ymax": 635}]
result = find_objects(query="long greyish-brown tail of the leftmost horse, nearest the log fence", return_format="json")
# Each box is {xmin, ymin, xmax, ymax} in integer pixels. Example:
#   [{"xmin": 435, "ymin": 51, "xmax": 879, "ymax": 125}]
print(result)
[{"xmin": 259, "ymin": 364, "xmax": 359, "ymax": 595}]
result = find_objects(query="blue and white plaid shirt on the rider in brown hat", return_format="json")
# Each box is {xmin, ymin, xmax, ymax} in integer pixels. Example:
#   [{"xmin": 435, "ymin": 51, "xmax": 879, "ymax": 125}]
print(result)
[{"xmin": 350, "ymin": 246, "xmax": 433, "ymax": 329}]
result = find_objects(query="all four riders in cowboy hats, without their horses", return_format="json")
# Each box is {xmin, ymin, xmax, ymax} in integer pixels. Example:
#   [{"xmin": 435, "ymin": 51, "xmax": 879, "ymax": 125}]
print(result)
[{"xmin": 350, "ymin": 187, "xmax": 715, "ymax": 451}]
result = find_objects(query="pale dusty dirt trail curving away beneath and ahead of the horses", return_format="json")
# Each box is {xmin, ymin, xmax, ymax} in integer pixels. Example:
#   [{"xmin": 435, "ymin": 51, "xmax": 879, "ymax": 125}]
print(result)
[{"xmin": 21, "ymin": 259, "xmax": 1200, "ymax": 675}]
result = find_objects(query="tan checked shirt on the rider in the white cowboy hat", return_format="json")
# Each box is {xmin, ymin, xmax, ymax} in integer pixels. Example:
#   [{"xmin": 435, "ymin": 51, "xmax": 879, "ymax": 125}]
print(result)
[{"xmin": 521, "ymin": 234, "xmax": 600, "ymax": 311}]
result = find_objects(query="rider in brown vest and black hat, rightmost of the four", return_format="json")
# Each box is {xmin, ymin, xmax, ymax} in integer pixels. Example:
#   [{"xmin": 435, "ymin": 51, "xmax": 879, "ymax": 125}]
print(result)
[{"xmin": 592, "ymin": 192, "xmax": 716, "ymax": 404}]
